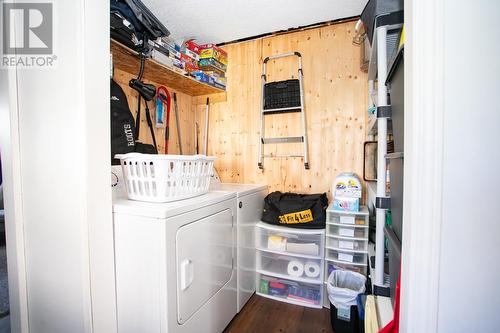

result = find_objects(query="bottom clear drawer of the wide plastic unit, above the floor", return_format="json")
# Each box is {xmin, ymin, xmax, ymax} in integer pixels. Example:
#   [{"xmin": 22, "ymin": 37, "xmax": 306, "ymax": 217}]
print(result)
[{"xmin": 257, "ymin": 274, "xmax": 323, "ymax": 308}]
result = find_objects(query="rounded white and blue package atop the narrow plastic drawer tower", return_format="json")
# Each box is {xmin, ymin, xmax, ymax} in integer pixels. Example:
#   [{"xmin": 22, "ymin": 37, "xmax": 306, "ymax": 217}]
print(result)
[{"xmin": 332, "ymin": 172, "xmax": 362, "ymax": 212}]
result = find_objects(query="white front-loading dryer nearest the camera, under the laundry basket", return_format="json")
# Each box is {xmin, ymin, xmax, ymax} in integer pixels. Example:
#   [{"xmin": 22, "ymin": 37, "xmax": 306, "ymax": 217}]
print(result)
[{"xmin": 113, "ymin": 191, "xmax": 237, "ymax": 333}]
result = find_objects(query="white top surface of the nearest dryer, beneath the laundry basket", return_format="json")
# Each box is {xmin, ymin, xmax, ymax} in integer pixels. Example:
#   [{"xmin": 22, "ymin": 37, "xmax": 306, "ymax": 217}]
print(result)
[{"xmin": 113, "ymin": 191, "xmax": 236, "ymax": 219}]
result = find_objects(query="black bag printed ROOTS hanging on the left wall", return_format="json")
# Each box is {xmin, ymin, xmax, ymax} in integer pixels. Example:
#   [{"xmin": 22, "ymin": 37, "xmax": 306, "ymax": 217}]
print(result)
[{"xmin": 110, "ymin": 80, "xmax": 135, "ymax": 165}]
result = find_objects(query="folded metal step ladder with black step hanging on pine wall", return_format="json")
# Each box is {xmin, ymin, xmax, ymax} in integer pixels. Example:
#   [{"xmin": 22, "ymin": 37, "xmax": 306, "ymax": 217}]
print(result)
[{"xmin": 258, "ymin": 52, "xmax": 309, "ymax": 170}]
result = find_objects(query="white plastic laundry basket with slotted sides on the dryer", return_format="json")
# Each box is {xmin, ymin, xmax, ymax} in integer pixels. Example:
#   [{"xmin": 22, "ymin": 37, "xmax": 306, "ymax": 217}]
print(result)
[{"xmin": 115, "ymin": 153, "xmax": 216, "ymax": 202}]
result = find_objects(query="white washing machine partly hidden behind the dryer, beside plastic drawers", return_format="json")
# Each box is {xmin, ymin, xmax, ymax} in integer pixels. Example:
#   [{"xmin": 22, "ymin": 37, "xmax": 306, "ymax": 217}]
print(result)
[{"xmin": 215, "ymin": 183, "xmax": 268, "ymax": 312}]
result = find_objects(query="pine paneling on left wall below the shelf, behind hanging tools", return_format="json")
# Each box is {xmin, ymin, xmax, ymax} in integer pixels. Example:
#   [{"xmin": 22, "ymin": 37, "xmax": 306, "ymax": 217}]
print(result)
[{"xmin": 113, "ymin": 68, "xmax": 195, "ymax": 154}]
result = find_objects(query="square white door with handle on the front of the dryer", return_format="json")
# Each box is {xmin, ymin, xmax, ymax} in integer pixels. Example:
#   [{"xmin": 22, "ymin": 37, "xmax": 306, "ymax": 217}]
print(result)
[{"xmin": 176, "ymin": 209, "xmax": 234, "ymax": 324}]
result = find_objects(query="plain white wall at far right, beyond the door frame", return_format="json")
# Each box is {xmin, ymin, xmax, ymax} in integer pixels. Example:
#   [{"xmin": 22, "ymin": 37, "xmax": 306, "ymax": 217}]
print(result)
[{"xmin": 438, "ymin": 0, "xmax": 500, "ymax": 333}]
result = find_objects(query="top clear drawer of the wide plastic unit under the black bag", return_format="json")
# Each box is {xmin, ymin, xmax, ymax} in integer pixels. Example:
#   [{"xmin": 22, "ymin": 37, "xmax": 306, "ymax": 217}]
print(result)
[{"xmin": 255, "ymin": 223, "xmax": 323, "ymax": 257}]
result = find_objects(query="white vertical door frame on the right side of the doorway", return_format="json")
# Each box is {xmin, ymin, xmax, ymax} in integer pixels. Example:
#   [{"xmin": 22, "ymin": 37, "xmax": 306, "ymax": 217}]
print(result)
[{"xmin": 400, "ymin": 0, "xmax": 445, "ymax": 333}]
